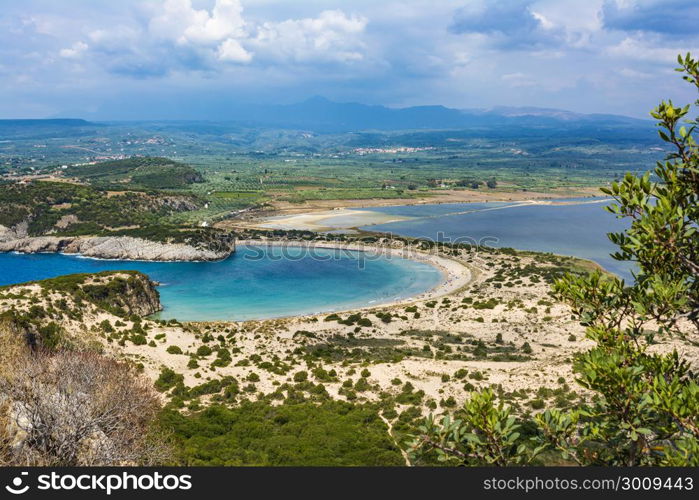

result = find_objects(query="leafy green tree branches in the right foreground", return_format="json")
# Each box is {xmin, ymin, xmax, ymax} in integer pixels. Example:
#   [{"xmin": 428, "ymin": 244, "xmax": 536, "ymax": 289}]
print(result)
[{"xmin": 412, "ymin": 54, "xmax": 699, "ymax": 466}]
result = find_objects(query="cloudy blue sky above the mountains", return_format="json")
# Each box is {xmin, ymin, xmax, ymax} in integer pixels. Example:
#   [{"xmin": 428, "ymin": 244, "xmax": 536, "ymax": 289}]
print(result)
[{"xmin": 0, "ymin": 0, "xmax": 699, "ymax": 120}]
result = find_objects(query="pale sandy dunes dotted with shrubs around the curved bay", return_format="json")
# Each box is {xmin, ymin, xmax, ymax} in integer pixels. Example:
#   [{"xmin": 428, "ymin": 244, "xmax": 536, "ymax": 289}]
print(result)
[{"xmin": 0, "ymin": 241, "xmax": 699, "ymax": 414}]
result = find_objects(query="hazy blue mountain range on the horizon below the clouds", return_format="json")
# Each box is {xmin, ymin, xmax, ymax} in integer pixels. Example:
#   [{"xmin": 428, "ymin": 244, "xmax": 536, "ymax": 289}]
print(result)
[{"xmin": 0, "ymin": 97, "xmax": 649, "ymax": 133}]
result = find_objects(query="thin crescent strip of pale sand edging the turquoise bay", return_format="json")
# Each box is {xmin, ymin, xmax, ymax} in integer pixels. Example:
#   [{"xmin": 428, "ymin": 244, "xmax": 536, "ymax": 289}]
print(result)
[{"xmin": 237, "ymin": 240, "xmax": 473, "ymax": 317}]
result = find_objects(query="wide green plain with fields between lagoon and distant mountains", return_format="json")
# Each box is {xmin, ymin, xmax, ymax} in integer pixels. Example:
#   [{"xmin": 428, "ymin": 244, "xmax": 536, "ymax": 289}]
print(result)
[{"xmin": 0, "ymin": 121, "xmax": 664, "ymax": 228}]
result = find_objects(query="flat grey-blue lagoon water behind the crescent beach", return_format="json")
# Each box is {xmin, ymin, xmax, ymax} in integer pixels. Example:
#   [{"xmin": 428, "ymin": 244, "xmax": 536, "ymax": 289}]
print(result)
[{"xmin": 362, "ymin": 200, "xmax": 633, "ymax": 280}]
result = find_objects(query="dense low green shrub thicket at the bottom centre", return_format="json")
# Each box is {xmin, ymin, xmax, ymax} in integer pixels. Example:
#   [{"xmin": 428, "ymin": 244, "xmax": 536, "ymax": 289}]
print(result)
[{"xmin": 156, "ymin": 401, "xmax": 403, "ymax": 466}]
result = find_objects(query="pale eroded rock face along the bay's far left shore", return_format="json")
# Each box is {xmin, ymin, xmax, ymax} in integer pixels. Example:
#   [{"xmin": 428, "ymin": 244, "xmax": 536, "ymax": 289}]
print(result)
[{"xmin": 0, "ymin": 232, "xmax": 235, "ymax": 261}]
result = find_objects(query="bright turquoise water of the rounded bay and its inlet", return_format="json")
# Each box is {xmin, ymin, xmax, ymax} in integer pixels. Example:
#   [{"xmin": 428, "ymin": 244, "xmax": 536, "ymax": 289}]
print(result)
[{"xmin": 0, "ymin": 247, "xmax": 441, "ymax": 321}]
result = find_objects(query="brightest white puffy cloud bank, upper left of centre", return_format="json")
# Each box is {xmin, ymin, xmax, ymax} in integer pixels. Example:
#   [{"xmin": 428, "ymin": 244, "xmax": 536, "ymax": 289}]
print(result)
[{"xmin": 89, "ymin": 0, "xmax": 367, "ymax": 71}]
